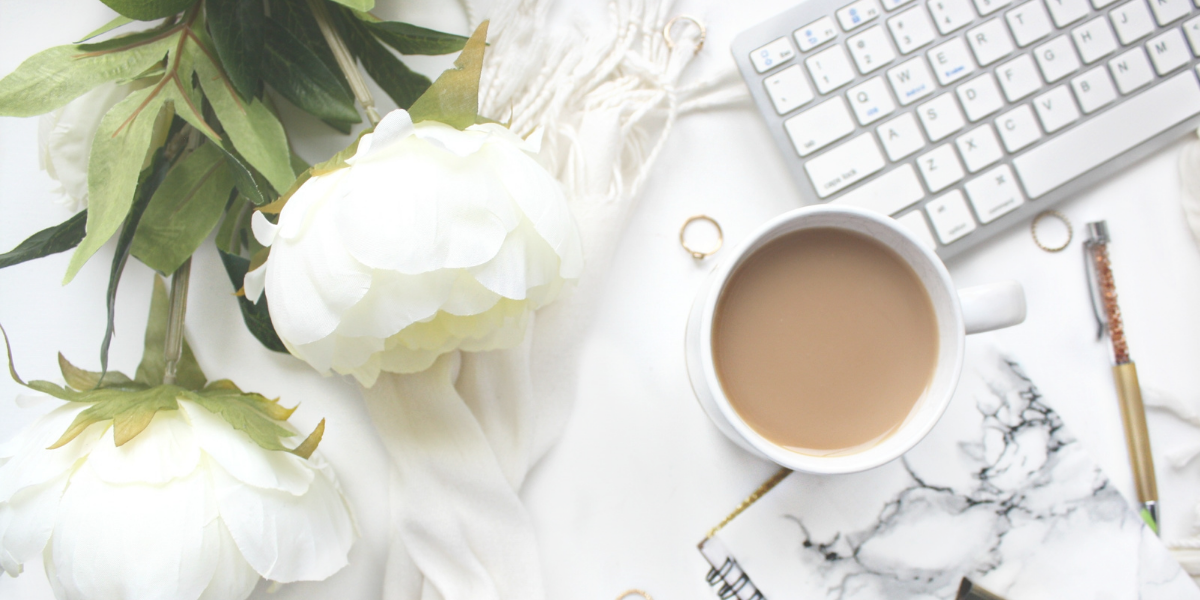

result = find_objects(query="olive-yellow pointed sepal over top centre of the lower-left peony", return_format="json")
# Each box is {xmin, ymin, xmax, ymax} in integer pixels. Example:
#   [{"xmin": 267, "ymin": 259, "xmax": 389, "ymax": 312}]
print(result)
[{"xmin": 47, "ymin": 385, "xmax": 187, "ymax": 450}]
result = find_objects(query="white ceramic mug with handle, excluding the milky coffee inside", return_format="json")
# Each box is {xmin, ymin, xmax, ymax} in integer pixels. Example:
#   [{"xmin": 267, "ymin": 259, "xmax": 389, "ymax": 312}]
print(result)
[{"xmin": 685, "ymin": 205, "xmax": 1025, "ymax": 474}]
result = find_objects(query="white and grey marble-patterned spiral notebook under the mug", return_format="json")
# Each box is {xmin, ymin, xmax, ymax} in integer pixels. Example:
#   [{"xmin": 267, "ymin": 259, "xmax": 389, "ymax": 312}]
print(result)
[{"xmin": 701, "ymin": 343, "xmax": 1200, "ymax": 600}]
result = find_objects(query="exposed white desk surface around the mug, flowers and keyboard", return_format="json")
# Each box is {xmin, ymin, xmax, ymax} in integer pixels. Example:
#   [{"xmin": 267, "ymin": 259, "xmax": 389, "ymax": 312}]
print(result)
[{"xmin": 7, "ymin": 0, "xmax": 1200, "ymax": 600}]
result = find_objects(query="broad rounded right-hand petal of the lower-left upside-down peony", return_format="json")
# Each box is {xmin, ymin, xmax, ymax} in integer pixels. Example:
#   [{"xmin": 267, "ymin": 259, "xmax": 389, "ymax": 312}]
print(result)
[{"xmin": 209, "ymin": 456, "xmax": 355, "ymax": 583}]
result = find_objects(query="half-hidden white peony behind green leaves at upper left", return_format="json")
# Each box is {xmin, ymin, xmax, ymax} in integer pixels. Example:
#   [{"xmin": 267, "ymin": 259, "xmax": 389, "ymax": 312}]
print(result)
[{"xmin": 37, "ymin": 83, "xmax": 131, "ymax": 212}]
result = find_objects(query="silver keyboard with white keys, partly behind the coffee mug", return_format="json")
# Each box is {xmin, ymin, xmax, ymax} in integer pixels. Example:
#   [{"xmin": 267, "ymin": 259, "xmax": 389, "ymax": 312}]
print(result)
[{"xmin": 733, "ymin": 0, "xmax": 1200, "ymax": 258}]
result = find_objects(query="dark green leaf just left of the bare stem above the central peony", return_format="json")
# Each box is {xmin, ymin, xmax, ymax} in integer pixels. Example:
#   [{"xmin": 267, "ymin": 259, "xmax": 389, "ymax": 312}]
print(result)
[{"xmin": 263, "ymin": 19, "xmax": 362, "ymax": 122}]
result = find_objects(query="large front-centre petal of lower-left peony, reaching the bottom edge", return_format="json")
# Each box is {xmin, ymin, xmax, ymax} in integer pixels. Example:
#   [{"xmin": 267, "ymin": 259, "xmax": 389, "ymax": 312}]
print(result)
[{"xmin": 53, "ymin": 463, "xmax": 221, "ymax": 600}]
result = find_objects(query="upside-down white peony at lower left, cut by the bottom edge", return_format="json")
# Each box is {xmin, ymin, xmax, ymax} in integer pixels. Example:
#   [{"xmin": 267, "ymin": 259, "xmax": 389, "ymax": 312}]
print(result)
[{"xmin": 0, "ymin": 400, "xmax": 355, "ymax": 600}]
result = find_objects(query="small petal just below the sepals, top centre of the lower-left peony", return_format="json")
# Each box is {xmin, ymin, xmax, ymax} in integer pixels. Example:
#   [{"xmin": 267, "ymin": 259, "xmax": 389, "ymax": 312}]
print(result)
[{"xmin": 88, "ymin": 410, "xmax": 200, "ymax": 484}]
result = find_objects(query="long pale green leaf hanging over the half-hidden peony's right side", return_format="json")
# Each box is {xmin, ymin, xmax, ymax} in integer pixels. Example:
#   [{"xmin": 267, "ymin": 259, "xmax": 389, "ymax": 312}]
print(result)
[{"xmin": 62, "ymin": 88, "xmax": 166, "ymax": 284}]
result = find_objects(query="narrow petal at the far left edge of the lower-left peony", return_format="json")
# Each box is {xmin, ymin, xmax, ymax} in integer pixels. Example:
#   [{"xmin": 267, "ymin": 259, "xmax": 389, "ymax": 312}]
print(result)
[{"xmin": 0, "ymin": 472, "xmax": 71, "ymax": 577}]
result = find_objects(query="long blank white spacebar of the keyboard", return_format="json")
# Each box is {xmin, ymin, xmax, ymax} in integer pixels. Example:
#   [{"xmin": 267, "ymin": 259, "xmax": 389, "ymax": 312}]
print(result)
[{"xmin": 1013, "ymin": 68, "xmax": 1200, "ymax": 198}]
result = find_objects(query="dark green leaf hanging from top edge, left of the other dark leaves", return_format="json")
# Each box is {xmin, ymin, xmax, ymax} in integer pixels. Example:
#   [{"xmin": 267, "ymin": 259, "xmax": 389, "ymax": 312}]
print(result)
[{"xmin": 204, "ymin": 0, "xmax": 266, "ymax": 102}]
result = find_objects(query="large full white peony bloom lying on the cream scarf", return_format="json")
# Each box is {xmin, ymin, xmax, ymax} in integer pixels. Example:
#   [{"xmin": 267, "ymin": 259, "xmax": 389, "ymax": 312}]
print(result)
[{"xmin": 246, "ymin": 110, "xmax": 583, "ymax": 386}]
